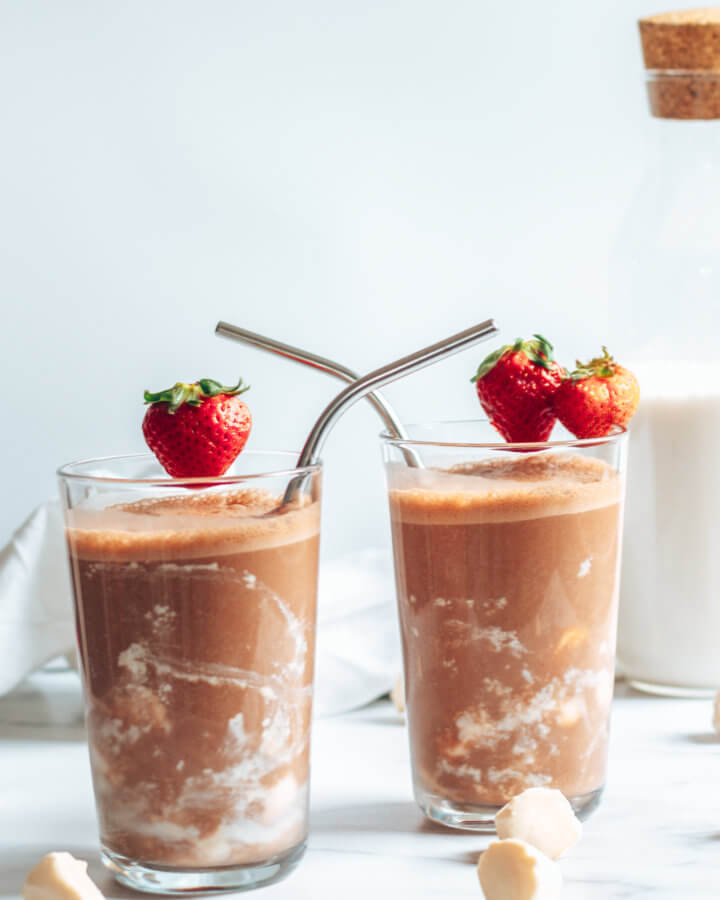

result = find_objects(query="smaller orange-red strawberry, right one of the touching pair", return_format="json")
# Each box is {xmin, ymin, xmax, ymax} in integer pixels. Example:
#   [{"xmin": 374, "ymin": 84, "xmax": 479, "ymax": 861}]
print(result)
[{"xmin": 553, "ymin": 347, "xmax": 640, "ymax": 438}]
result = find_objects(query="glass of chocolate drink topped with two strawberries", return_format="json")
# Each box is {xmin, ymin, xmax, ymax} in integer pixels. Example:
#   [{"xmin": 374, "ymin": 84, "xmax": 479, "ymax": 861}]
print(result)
[{"xmin": 382, "ymin": 422, "xmax": 626, "ymax": 830}]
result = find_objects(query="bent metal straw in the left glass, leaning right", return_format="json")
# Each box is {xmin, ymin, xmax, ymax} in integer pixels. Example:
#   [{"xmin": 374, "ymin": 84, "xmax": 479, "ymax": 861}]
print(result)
[{"xmin": 260, "ymin": 319, "xmax": 498, "ymax": 512}]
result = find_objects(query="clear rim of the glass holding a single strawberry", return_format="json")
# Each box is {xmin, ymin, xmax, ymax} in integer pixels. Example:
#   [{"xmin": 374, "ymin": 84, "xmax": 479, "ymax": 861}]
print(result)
[{"xmin": 56, "ymin": 450, "xmax": 322, "ymax": 487}]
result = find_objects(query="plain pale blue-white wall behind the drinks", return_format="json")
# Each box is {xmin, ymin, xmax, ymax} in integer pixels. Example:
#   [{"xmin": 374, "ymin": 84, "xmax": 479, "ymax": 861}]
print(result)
[{"xmin": 0, "ymin": 0, "xmax": 661, "ymax": 555}]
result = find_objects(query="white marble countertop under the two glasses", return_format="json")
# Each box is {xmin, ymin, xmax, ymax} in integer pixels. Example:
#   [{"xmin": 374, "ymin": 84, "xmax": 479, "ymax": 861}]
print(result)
[{"xmin": 0, "ymin": 672, "xmax": 720, "ymax": 900}]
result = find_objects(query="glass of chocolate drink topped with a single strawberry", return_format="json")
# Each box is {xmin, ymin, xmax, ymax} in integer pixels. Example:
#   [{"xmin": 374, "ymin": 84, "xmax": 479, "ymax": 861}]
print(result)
[{"xmin": 58, "ymin": 453, "xmax": 320, "ymax": 893}]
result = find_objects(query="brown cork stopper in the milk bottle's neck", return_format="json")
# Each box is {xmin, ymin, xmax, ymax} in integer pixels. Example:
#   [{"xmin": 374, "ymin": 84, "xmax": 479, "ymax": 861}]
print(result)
[{"xmin": 638, "ymin": 7, "xmax": 720, "ymax": 119}]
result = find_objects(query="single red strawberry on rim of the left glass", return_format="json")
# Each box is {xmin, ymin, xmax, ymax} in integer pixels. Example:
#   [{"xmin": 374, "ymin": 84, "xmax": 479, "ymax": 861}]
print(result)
[{"xmin": 143, "ymin": 378, "xmax": 252, "ymax": 478}]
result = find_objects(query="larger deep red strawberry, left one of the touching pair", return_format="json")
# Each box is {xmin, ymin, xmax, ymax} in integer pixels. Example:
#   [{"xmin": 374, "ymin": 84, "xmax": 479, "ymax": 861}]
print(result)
[{"xmin": 472, "ymin": 334, "xmax": 565, "ymax": 443}]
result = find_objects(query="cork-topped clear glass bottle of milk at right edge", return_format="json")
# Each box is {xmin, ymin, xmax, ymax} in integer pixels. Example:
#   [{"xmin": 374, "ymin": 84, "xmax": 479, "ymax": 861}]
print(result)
[{"xmin": 611, "ymin": 10, "xmax": 720, "ymax": 695}]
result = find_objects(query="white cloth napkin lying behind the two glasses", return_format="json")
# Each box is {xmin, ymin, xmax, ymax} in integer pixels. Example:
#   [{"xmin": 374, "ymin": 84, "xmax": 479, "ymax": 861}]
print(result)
[{"xmin": 0, "ymin": 501, "xmax": 401, "ymax": 716}]
